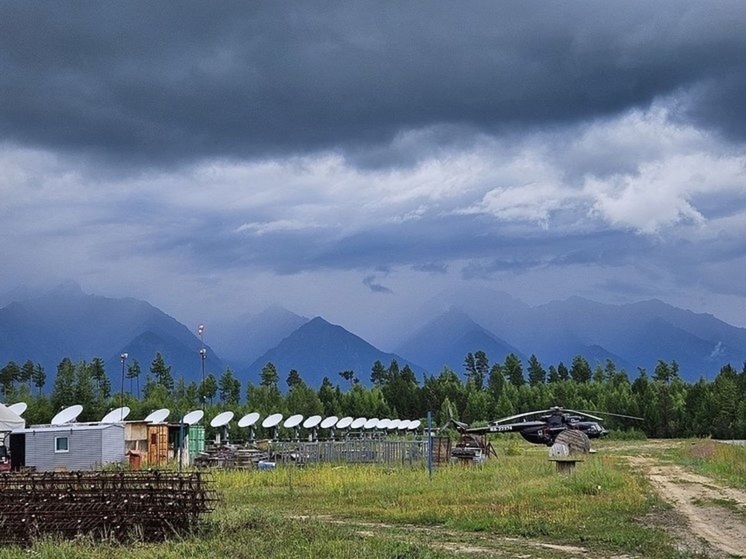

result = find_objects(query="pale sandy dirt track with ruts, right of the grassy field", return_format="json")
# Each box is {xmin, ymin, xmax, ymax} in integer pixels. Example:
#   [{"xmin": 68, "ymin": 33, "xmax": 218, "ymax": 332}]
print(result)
[{"xmin": 629, "ymin": 456, "xmax": 746, "ymax": 557}]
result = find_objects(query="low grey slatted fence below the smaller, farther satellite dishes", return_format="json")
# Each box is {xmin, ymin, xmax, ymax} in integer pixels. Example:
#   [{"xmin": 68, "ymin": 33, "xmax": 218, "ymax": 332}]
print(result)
[{"xmin": 270, "ymin": 440, "xmax": 428, "ymax": 466}]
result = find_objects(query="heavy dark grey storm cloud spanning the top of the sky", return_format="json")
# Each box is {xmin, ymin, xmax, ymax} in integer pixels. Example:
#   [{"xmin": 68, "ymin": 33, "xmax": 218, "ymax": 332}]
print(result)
[{"xmin": 0, "ymin": 1, "xmax": 746, "ymax": 166}]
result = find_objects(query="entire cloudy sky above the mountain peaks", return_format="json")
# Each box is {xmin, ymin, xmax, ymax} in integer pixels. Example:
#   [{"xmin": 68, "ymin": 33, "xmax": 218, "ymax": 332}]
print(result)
[{"xmin": 0, "ymin": 0, "xmax": 746, "ymax": 349}]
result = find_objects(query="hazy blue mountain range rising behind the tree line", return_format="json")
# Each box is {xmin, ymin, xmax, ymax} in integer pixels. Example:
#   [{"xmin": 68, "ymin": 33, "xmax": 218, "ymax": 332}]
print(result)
[{"xmin": 0, "ymin": 283, "xmax": 746, "ymax": 387}]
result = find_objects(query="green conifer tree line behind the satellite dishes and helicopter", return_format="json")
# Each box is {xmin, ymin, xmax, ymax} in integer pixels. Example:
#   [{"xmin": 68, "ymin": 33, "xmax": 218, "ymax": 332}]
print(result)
[{"xmin": 0, "ymin": 351, "xmax": 746, "ymax": 438}]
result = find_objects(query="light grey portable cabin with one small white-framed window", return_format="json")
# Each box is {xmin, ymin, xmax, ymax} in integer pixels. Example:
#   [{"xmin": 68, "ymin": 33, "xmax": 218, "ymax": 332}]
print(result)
[{"xmin": 10, "ymin": 423, "xmax": 125, "ymax": 472}]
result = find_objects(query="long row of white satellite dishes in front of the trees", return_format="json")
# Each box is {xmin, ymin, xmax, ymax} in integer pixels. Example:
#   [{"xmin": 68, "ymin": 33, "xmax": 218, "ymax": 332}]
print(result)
[{"xmin": 8, "ymin": 402, "xmax": 422, "ymax": 431}]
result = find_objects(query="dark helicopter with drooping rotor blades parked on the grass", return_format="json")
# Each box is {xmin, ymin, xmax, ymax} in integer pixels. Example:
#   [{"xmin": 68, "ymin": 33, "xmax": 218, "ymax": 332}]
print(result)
[{"xmin": 451, "ymin": 406, "xmax": 642, "ymax": 446}]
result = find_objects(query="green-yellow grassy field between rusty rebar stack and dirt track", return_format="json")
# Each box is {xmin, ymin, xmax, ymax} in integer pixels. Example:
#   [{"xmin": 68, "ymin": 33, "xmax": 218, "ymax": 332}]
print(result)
[{"xmin": 3, "ymin": 441, "xmax": 732, "ymax": 559}]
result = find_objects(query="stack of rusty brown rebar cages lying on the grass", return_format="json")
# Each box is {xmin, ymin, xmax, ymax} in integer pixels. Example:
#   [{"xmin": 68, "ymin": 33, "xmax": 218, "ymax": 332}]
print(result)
[{"xmin": 0, "ymin": 470, "xmax": 217, "ymax": 545}]
